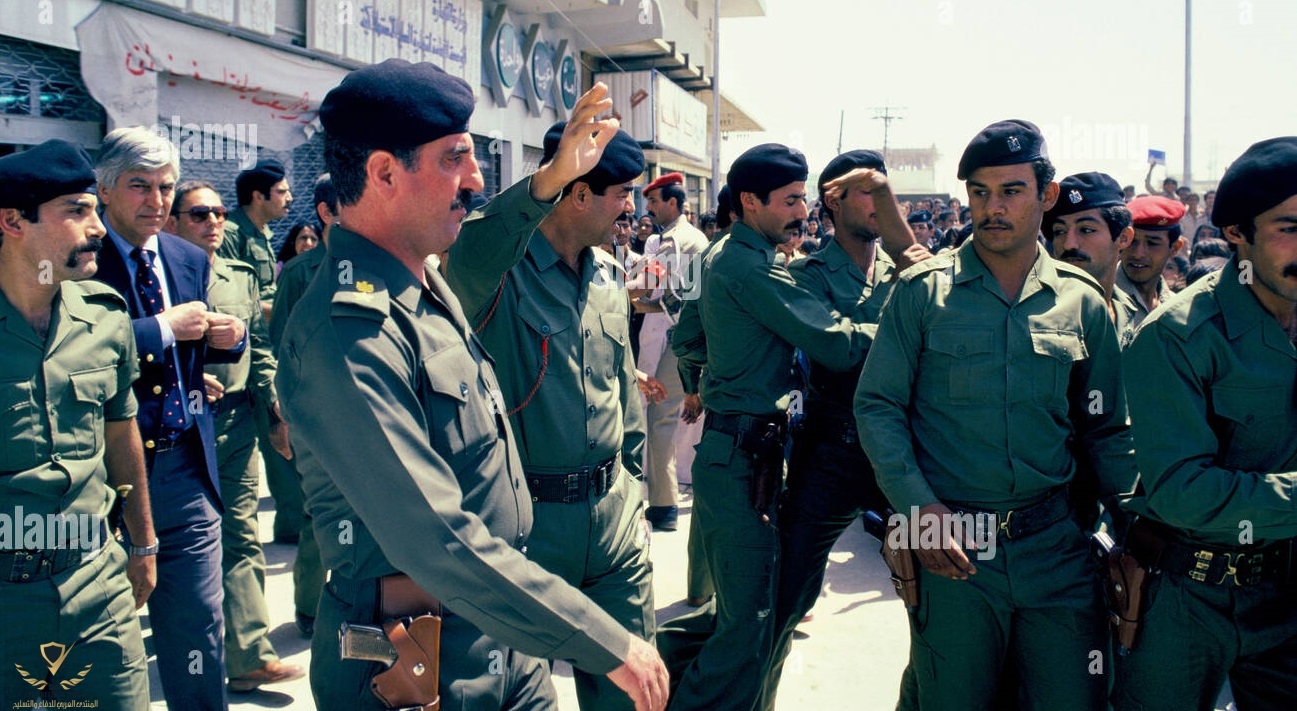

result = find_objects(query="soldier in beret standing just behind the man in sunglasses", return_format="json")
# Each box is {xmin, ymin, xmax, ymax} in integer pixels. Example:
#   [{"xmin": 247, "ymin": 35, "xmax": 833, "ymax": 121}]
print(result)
[{"xmin": 224, "ymin": 160, "xmax": 303, "ymax": 545}]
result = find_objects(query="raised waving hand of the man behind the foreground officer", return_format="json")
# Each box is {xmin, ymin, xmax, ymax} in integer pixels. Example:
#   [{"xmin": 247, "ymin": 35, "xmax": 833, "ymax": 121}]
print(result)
[{"xmin": 532, "ymin": 82, "xmax": 621, "ymax": 202}]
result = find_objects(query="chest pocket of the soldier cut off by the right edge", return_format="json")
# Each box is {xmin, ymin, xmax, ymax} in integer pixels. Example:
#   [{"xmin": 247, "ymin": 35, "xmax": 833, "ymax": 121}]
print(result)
[{"xmin": 1211, "ymin": 385, "xmax": 1293, "ymax": 471}]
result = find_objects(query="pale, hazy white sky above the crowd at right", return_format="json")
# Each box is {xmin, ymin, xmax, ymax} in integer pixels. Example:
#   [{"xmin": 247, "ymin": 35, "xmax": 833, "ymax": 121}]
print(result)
[{"xmin": 720, "ymin": 0, "xmax": 1297, "ymax": 197}]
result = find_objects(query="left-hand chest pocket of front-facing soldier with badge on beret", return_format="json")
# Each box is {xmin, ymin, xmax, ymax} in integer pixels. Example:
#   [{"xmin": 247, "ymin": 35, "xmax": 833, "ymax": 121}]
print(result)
[{"xmin": 922, "ymin": 328, "xmax": 1001, "ymax": 405}]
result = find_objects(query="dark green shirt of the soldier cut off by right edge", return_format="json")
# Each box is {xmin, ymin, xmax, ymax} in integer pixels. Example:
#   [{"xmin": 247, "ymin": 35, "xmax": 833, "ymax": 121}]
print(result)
[{"xmin": 1123, "ymin": 259, "xmax": 1297, "ymax": 546}]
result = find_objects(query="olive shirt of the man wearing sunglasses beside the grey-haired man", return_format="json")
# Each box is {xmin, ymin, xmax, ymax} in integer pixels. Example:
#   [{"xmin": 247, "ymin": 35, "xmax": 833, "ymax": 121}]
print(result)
[{"xmin": 202, "ymin": 257, "xmax": 278, "ymax": 409}]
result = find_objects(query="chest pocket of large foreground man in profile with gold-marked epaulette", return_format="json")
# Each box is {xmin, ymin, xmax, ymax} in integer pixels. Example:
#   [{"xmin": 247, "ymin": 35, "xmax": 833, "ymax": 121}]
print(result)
[{"xmin": 423, "ymin": 346, "xmax": 495, "ymax": 461}]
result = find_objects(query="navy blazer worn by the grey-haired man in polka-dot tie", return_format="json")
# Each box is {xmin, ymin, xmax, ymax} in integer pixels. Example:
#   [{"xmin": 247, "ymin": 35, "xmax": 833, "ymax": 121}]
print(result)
[{"xmin": 95, "ymin": 232, "xmax": 248, "ymax": 506}]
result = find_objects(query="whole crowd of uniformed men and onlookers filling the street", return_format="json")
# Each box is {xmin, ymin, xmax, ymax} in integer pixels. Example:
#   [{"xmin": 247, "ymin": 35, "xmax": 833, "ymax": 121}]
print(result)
[{"xmin": 0, "ymin": 54, "xmax": 1297, "ymax": 711}]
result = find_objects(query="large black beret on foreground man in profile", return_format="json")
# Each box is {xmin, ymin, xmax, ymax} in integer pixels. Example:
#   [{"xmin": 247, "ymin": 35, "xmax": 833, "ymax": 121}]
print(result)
[{"xmin": 319, "ymin": 60, "xmax": 476, "ymax": 149}]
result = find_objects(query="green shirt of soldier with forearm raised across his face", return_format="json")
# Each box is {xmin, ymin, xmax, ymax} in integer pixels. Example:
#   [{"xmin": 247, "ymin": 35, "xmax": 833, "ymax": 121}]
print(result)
[{"xmin": 789, "ymin": 240, "xmax": 896, "ymax": 419}]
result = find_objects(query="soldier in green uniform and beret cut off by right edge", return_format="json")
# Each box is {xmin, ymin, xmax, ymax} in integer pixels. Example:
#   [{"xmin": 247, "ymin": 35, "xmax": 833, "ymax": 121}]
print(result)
[{"xmin": 1114, "ymin": 136, "xmax": 1297, "ymax": 711}]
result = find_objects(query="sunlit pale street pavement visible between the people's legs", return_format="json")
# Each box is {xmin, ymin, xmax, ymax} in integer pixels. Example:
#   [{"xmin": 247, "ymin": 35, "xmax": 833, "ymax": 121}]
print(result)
[{"xmin": 145, "ymin": 480, "xmax": 1228, "ymax": 711}]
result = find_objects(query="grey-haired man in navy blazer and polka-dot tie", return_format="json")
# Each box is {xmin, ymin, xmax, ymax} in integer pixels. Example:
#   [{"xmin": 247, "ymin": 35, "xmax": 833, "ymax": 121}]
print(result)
[{"xmin": 95, "ymin": 127, "xmax": 246, "ymax": 710}]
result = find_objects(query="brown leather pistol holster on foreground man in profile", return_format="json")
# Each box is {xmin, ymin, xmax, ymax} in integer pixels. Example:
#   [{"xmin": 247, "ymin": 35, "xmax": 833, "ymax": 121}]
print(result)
[{"xmin": 370, "ymin": 615, "xmax": 441, "ymax": 711}]
